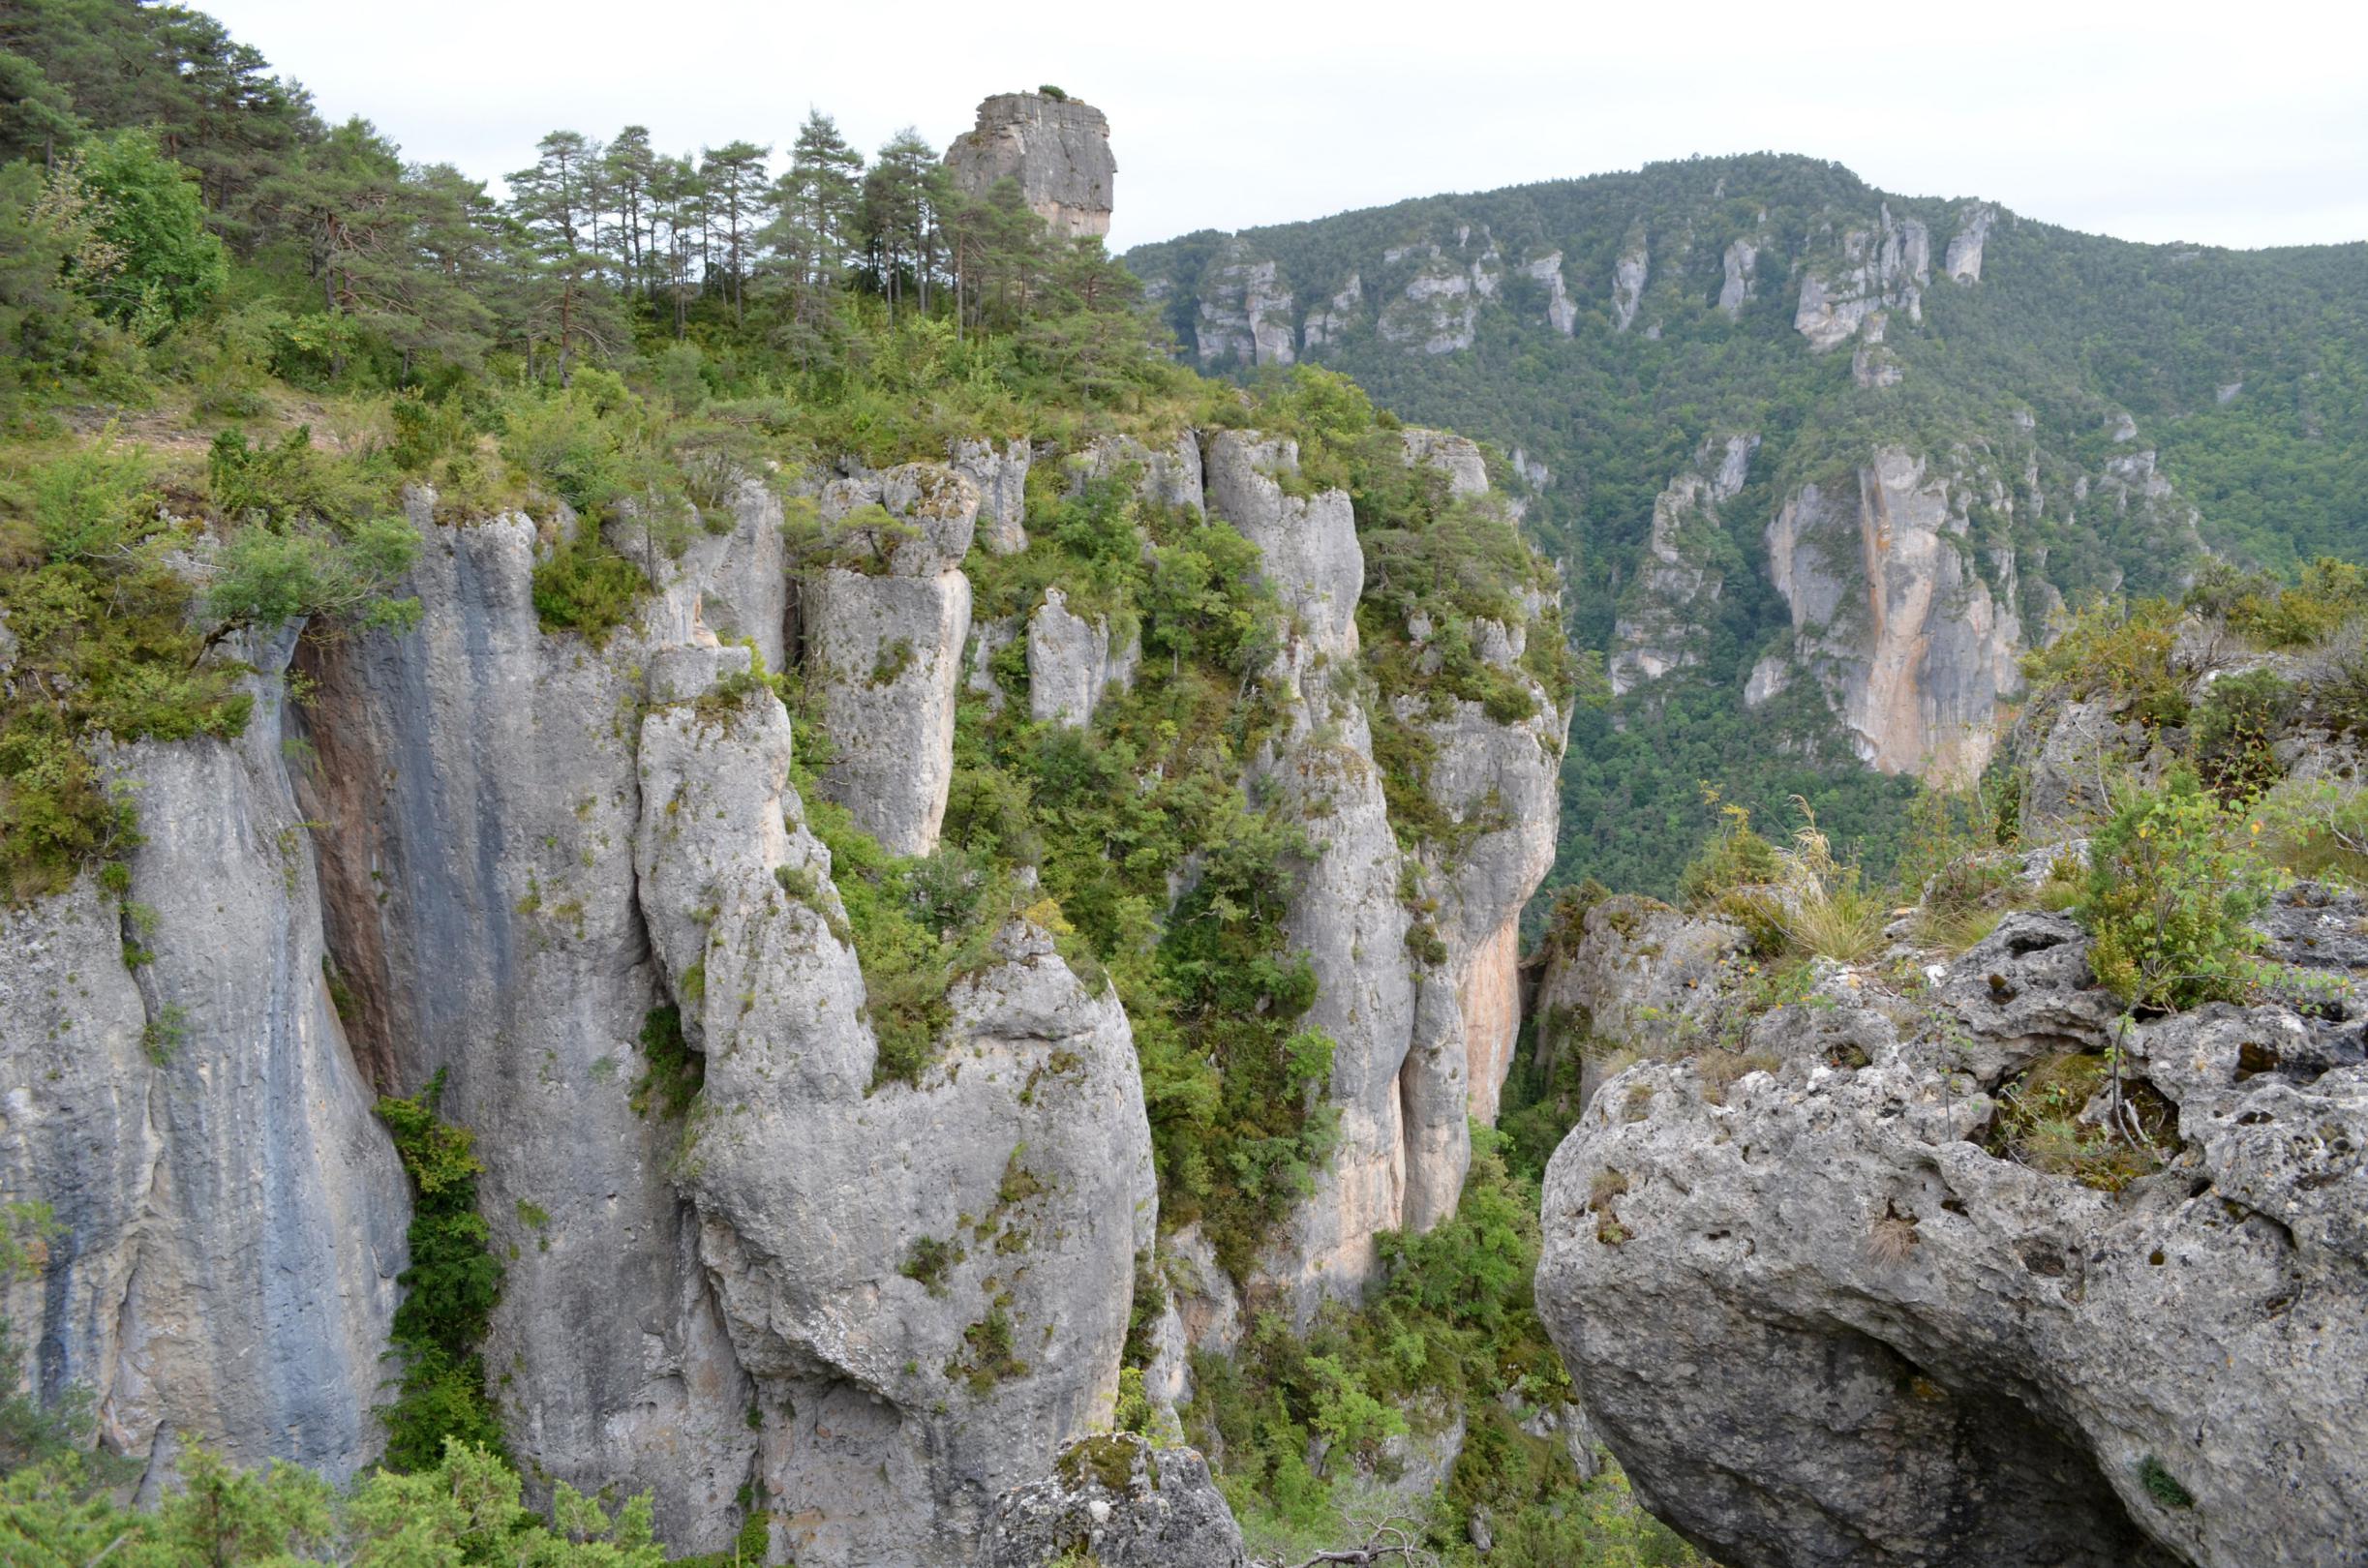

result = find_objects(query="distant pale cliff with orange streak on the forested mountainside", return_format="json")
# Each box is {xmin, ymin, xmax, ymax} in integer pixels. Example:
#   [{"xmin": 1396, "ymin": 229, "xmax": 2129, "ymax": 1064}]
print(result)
[{"xmin": 1767, "ymin": 448, "xmax": 2022, "ymax": 779}]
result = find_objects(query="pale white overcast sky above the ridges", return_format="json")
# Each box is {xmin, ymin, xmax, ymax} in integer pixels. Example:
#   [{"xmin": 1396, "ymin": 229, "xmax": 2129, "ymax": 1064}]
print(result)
[{"xmin": 208, "ymin": 0, "xmax": 2368, "ymax": 249}]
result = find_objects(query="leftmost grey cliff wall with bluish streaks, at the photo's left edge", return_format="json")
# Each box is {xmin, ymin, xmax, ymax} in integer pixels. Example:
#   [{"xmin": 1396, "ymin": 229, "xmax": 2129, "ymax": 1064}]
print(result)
[{"xmin": 0, "ymin": 632, "xmax": 410, "ymax": 1497}]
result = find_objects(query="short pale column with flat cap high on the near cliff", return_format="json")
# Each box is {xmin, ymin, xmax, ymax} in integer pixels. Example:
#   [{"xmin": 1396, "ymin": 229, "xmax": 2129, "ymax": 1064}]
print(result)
[{"xmin": 803, "ymin": 462, "xmax": 978, "ymax": 855}]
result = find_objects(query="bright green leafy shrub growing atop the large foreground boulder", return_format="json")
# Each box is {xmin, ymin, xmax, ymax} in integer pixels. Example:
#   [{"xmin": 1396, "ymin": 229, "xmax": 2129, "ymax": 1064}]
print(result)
[{"xmin": 2075, "ymin": 768, "xmax": 2283, "ymax": 1011}]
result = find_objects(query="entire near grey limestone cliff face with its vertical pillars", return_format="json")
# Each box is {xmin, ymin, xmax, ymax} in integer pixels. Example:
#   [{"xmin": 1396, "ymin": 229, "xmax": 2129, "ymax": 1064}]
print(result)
[{"xmin": 0, "ymin": 411, "xmax": 1563, "ymax": 1566}]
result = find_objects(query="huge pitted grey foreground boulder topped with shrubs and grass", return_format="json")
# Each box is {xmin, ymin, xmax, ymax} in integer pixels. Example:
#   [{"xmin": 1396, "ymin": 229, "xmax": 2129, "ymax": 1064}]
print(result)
[{"xmin": 1536, "ymin": 563, "xmax": 2368, "ymax": 1566}]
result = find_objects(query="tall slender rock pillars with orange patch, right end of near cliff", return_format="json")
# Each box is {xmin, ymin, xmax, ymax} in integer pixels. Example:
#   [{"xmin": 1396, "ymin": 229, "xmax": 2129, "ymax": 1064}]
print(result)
[{"xmin": 1207, "ymin": 431, "xmax": 1567, "ymax": 1321}]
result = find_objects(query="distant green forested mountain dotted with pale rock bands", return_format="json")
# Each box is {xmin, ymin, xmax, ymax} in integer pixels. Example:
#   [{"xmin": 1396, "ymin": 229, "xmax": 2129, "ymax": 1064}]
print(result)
[{"xmin": 1127, "ymin": 154, "xmax": 2368, "ymax": 890}]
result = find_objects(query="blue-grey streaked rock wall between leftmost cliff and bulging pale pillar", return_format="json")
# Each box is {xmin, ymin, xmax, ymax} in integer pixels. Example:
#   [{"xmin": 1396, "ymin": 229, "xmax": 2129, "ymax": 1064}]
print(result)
[{"xmin": 293, "ymin": 498, "xmax": 757, "ymax": 1547}]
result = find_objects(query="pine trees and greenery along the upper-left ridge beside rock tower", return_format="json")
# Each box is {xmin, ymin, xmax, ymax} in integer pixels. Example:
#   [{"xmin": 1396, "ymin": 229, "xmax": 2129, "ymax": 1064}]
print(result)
[{"xmin": 0, "ymin": 0, "xmax": 1141, "ymax": 405}]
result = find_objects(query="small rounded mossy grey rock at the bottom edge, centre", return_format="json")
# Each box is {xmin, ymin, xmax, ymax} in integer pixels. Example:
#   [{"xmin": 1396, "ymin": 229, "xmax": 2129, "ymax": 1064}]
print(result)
[{"xmin": 978, "ymin": 1433, "xmax": 1248, "ymax": 1568}]
